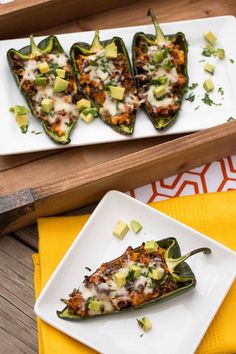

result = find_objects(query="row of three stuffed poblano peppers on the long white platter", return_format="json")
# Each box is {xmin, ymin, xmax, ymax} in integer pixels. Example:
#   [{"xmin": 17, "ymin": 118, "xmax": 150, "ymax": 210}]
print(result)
[{"xmin": 7, "ymin": 10, "xmax": 188, "ymax": 144}]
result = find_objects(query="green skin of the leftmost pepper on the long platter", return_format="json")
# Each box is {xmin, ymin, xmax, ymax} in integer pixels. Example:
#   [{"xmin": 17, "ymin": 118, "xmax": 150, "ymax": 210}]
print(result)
[{"xmin": 7, "ymin": 36, "xmax": 85, "ymax": 145}]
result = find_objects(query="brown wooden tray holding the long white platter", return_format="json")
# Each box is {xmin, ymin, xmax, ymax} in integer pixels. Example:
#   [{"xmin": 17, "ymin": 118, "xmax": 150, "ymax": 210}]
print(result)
[{"xmin": 0, "ymin": 0, "xmax": 236, "ymax": 233}]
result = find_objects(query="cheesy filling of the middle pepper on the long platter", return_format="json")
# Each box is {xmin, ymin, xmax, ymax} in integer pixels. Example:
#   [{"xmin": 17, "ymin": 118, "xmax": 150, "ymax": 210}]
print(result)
[{"xmin": 77, "ymin": 49, "xmax": 139, "ymax": 126}]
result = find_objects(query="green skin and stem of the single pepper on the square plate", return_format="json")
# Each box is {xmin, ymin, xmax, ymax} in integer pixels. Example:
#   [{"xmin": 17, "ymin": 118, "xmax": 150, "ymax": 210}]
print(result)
[{"xmin": 57, "ymin": 237, "xmax": 211, "ymax": 321}]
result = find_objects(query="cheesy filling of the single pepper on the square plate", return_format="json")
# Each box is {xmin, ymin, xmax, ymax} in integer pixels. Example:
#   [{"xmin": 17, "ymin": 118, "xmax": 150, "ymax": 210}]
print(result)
[{"xmin": 66, "ymin": 243, "xmax": 182, "ymax": 316}]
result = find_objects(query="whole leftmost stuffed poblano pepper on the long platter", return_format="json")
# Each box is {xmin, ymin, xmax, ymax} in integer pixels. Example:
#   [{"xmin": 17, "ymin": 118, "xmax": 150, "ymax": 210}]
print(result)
[{"xmin": 7, "ymin": 35, "xmax": 94, "ymax": 144}]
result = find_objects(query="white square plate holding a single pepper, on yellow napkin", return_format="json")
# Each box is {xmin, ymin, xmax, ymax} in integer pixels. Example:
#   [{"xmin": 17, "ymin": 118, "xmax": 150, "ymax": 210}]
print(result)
[{"xmin": 35, "ymin": 191, "xmax": 236, "ymax": 354}]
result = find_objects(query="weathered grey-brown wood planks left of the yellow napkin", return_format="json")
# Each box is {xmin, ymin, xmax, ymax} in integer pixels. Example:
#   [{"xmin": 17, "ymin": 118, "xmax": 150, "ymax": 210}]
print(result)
[{"xmin": 0, "ymin": 235, "xmax": 37, "ymax": 354}]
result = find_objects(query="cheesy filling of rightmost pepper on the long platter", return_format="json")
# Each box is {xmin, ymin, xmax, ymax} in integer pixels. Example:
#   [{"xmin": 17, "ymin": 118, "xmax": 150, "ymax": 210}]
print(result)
[{"xmin": 135, "ymin": 37, "xmax": 187, "ymax": 117}]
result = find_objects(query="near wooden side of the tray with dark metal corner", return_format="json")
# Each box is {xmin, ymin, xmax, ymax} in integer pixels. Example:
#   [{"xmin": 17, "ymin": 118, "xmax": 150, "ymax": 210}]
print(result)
[{"xmin": 0, "ymin": 122, "xmax": 236, "ymax": 233}]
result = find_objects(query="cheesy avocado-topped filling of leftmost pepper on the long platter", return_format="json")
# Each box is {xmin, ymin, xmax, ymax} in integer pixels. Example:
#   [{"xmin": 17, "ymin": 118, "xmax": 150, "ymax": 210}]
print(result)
[{"xmin": 13, "ymin": 53, "xmax": 82, "ymax": 136}]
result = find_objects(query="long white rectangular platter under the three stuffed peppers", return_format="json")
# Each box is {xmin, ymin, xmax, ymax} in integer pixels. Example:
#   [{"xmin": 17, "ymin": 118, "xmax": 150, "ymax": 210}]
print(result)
[{"xmin": 0, "ymin": 16, "xmax": 236, "ymax": 155}]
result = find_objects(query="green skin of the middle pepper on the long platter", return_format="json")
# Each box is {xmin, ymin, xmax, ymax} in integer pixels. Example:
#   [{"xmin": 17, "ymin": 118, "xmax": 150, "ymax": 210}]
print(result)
[{"xmin": 70, "ymin": 32, "xmax": 136, "ymax": 135}]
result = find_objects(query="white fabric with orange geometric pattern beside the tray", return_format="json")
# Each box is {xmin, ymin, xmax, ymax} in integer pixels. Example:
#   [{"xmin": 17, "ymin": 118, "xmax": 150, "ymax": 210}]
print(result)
[{"xmin": 129, "ymin": 155, "xmax": 236, "ymax": 203}]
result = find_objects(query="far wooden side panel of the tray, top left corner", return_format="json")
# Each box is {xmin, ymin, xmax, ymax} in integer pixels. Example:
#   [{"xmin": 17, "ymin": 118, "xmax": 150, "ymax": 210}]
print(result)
[{"xmin": 0, "ymin": 0, "xmax": 134, "ymax": 39}]
